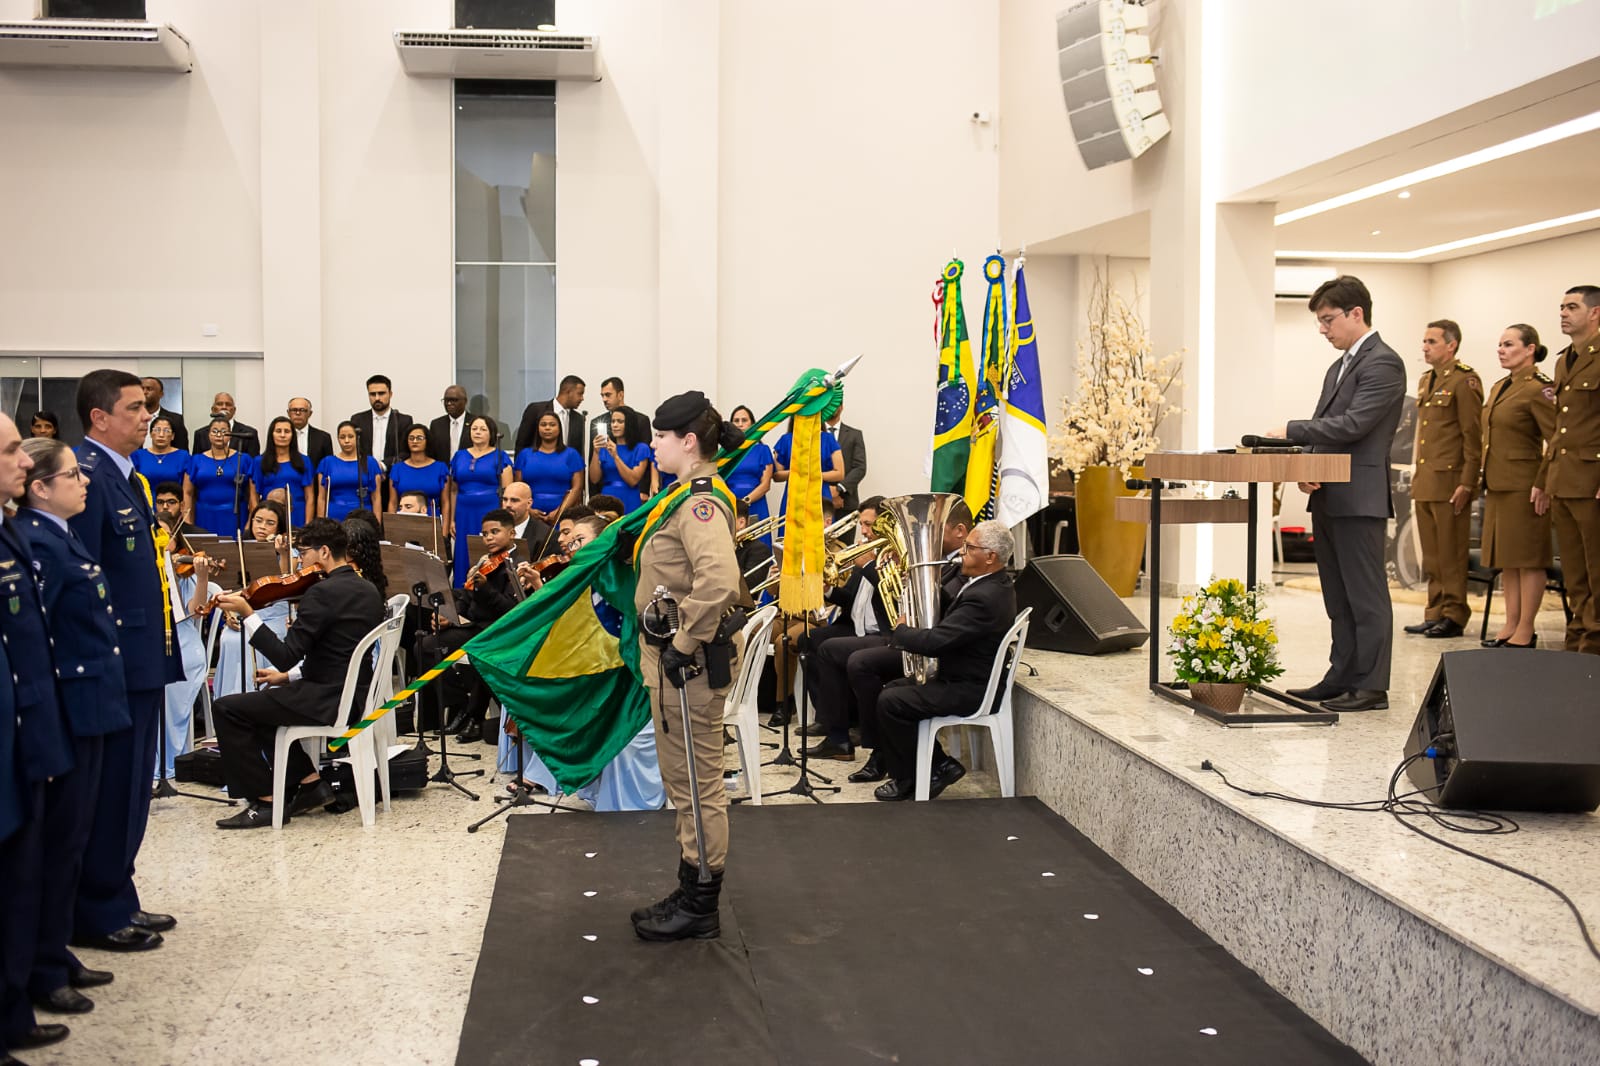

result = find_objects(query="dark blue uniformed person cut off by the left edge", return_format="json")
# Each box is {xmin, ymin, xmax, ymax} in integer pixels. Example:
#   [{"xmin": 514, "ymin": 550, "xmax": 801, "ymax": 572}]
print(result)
[{"xmin": 0, "ymin": 416, "xmax": 78, "ymax": 1050}]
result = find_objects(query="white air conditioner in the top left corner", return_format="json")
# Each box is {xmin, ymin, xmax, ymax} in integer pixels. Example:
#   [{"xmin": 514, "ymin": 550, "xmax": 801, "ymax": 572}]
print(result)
[{"xmin": 0, "ymin": 19, "xmax": 195, "ymax": 74}]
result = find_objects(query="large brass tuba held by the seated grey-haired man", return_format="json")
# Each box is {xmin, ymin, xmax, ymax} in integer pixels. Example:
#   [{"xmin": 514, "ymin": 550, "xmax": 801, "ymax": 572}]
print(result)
[{"xmin": 872, "ymin": 493, "xmax": 962, "ymax": 685}]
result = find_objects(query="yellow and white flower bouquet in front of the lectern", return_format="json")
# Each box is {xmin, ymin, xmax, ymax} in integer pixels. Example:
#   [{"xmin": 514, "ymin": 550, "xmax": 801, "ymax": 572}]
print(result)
[{"xmin": 1166, "ymin": 578, "xmax": 1283, "ymax": 685}]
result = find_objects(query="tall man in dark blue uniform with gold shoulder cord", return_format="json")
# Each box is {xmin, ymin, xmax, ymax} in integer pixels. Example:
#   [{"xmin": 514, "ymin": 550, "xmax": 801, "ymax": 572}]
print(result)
[{"xmin": 69, "ymin": 370, "xmax": 179, "ymax": 951}]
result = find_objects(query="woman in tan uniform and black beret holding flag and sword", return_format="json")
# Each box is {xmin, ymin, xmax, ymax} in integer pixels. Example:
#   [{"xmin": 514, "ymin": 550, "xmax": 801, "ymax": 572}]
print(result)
[{"xmin": 634, "ymin": 392, "xmax": 742, "ymax": 940}]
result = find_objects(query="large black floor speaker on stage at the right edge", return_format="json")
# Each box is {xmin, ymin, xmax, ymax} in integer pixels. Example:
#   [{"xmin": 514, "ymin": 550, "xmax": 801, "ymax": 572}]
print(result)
[{"xmin": 1405, "ymin": 648, "xmax": 1600, "ymax": 812}]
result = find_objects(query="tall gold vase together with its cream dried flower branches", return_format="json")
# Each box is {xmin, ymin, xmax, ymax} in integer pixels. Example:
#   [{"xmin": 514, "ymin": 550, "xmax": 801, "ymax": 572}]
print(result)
[{"xmin": 1050, "ymin": 275, "xmax": 1182, "ymax": 595}]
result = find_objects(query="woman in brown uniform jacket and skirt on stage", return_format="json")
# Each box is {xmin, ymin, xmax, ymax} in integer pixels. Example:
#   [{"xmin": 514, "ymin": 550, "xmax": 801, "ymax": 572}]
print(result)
[{"xmin": 1483, "ymin": 323, "xmax": 1555, "ymax": 648}]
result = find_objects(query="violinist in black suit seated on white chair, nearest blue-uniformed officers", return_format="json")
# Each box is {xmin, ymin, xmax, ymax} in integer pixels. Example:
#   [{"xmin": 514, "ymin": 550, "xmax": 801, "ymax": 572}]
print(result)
[{"xmin": 214, "ymin": 519, "xmax": 384, "ymax": 829}]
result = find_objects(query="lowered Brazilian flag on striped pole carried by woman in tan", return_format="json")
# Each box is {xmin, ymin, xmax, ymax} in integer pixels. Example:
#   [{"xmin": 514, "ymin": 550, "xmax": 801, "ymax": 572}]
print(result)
[{"xmin": 320, "ymin": 360, "xmax": 854, "ymax": 791}]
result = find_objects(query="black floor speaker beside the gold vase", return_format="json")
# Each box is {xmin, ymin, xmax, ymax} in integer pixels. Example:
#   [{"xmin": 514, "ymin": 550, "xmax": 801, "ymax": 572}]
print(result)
[{"xmin": 1016, "ymin": 555, "xmax": 1150, "ymax": 655}]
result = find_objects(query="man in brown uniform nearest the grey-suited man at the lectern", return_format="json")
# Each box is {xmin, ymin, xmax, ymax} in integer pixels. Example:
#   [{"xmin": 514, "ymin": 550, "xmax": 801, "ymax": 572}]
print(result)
[{"xmin": 1405, "ymin": 319, "xmax": 1483, "ymax": 637}]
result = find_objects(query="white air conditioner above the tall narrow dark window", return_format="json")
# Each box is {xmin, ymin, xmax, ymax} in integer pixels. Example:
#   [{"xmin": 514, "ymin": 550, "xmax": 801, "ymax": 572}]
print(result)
[{"xmin": 395, "ymin": 29, "xmax": 600, "ymax": 82}]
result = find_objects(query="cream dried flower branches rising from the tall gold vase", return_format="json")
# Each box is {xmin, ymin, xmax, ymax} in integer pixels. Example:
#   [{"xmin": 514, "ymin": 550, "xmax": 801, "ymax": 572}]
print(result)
[{"xmin": 1050, "ymin": 275, "xmax": 1184, "ymax": 474}]
